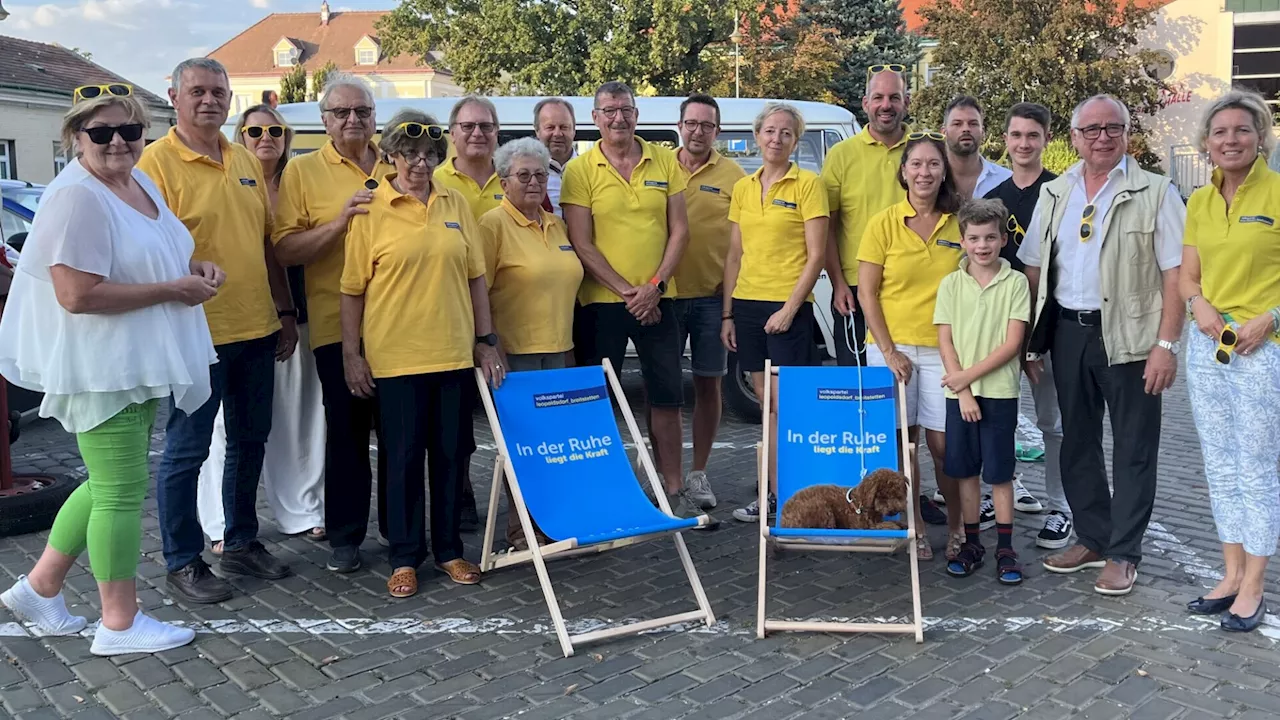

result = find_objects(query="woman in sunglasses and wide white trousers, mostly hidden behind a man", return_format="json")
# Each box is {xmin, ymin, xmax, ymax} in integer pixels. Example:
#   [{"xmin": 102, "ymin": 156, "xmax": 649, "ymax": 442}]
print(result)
[{"xmin": 197, "ymin": 105, "xmax": 325, "ymax": 555}]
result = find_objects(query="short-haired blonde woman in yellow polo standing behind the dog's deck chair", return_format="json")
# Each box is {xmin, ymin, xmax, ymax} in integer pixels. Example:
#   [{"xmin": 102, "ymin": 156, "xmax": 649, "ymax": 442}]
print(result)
[{"xmin": 721, "ymin": 102, "xmax": 829, "ymax": 519}]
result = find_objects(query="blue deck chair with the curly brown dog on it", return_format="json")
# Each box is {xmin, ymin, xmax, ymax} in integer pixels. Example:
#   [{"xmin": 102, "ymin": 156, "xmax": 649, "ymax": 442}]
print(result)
[{"xmin": 755, "ymin": 363, "xmax": 924, "ymax": 642}]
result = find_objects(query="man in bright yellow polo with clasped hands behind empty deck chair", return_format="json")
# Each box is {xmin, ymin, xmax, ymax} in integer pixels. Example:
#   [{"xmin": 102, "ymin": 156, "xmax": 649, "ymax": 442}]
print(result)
[{"xmin": 561, "ymin": 82, "xmax": 700, "ymax": 516}]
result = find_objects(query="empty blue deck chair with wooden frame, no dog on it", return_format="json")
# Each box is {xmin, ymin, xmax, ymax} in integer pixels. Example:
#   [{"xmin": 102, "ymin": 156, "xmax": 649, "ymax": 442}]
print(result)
[{"xmin": 476, "ymin": 360, "xmax": 716, "ymax": 657}]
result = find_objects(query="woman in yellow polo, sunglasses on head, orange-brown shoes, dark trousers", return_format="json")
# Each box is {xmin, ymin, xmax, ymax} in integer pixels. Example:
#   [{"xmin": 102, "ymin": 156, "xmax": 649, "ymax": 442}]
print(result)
[{"xmin": 342, "ymin": 110, "xmax": 503, "ymax": 597}]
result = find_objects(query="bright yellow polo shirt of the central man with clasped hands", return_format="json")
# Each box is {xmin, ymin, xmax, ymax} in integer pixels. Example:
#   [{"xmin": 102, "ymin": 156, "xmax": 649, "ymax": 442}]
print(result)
[{"xmin": 561, "ymin": 137, "xmax": 685, "ymax": 305}]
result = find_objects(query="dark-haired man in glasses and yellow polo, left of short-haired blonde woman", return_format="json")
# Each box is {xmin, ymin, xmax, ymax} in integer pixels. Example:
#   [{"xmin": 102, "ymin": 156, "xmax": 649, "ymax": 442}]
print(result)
[{"xmin": 676, "ymin": 94, "xmax": 745, "ymax": 510}]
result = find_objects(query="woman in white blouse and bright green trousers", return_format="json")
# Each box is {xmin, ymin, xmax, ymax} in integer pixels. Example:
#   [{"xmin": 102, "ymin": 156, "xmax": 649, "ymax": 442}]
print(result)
[{"xmin": 0, "ymin": 94, "xmax": 224, "ymax": 655}]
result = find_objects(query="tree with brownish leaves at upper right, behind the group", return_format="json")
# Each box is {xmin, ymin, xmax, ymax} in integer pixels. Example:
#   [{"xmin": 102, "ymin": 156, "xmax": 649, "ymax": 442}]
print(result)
[{"xmin": 911, "ymin": 0, "xmax": 1162, "ymax": 168}]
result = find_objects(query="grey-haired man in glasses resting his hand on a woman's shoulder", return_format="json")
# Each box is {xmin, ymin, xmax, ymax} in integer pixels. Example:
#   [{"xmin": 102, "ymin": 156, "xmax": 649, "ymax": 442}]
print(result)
[{"xmin": 271, "ymin": 74, "xmax": 396, "ymax": 573}]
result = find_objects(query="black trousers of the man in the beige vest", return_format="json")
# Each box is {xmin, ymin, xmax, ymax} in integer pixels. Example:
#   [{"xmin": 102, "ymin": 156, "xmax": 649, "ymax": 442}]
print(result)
[{"xmin": 1053, "ymin": 319, "xmax": 1161, "ymax": 564}]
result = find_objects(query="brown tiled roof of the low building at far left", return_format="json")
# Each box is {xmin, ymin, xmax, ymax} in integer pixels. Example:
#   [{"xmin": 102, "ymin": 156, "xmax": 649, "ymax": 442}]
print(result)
[{"xmin": 0, "ymin": 35, "xmax": 169, "ymax": 108}]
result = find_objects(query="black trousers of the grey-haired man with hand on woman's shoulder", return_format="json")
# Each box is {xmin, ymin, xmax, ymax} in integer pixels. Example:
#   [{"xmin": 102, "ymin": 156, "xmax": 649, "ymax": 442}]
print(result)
[{"xmin": 315, "ymin": 342, "xmax": 387, "ymax": 548}]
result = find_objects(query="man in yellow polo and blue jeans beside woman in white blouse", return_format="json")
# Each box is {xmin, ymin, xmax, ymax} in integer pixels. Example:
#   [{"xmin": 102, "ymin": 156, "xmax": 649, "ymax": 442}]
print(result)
[{"xmin": 138, "ymin": 58, "xmax": 297, "ymax": 603}]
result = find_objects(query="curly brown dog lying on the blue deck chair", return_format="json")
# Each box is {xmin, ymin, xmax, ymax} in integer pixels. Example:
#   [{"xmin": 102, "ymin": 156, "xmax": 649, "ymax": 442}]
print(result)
[{"xmin": 782, "ymin": 469, "xmax": 908, "ymax": 530}]
